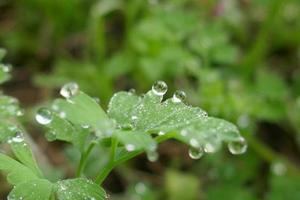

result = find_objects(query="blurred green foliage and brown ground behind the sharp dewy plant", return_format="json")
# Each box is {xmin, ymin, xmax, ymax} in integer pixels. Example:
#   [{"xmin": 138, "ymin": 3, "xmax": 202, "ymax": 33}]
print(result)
[{"xmin": 0, "ymin": 0, "xmax": 300, "ymax": 200}]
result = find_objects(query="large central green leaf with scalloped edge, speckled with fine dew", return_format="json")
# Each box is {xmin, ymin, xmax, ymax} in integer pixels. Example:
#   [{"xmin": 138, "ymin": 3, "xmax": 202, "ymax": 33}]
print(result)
[{"xmin": 108, "ymin": 91, "xmax": 241, "ymax": 152}]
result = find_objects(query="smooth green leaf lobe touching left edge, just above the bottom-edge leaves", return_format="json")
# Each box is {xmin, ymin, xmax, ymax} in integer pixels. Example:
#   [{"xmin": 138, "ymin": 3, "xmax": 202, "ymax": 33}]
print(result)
[{"xmin": 0, "ymin": 154, "xmax": 38, "ymax": 185}]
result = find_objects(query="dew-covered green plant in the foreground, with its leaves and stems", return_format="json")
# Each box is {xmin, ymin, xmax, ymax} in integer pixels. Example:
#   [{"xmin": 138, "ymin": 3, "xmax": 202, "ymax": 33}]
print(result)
[{"xmin": 0, "ymin": 55, "xmax": 247, "ymax": 200}]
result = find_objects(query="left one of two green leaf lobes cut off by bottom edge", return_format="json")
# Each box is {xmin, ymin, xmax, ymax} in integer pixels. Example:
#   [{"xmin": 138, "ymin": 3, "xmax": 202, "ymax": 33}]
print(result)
[{"xmin": 8, "ymin": 179, "xmax": 53, "ymax": 200}]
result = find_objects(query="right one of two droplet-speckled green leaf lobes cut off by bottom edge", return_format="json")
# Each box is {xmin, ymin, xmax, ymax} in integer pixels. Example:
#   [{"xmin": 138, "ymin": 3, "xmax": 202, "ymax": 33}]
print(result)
[{"xmin": 55, "ymin": 178, "xmax": 106, "ymax": 200}]
